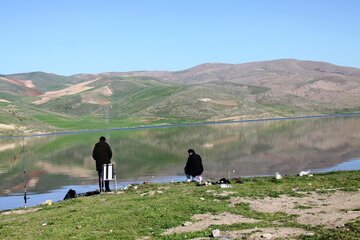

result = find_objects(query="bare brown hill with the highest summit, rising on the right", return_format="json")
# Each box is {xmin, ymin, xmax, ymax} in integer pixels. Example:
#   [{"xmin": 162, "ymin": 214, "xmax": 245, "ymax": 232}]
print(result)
[{"xmin": 102, "ymin": 59, "xmax": 360, "ymax": 112}]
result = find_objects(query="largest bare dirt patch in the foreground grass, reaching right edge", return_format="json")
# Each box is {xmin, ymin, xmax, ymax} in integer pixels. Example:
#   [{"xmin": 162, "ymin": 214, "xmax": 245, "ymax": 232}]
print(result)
[{"xmin": 231, "ymin": 191, "xmax": 360, "ymax": 228}]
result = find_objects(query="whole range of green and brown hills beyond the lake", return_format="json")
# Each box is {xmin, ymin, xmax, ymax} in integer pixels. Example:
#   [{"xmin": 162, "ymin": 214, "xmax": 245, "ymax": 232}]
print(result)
[{"xmin": 0, "ymin": 59, "xmax": 360, "ymax": 134}]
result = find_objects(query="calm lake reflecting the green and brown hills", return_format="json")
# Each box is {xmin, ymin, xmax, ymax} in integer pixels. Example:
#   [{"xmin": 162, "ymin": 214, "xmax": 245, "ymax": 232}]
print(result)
[{"xmin": 0, "ymin": 116, "xmax": 360, "ymax": 209}]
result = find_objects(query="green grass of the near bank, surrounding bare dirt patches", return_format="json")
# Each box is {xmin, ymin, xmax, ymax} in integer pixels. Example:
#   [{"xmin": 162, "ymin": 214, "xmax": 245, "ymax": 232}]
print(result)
[{"xmin": 0, "ymin": 171, "xmax": 360, "ymax": 239}]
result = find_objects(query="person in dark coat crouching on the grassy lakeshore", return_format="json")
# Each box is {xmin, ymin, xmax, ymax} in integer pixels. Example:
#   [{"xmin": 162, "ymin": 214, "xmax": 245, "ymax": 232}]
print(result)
[{"xmin": 184, "ymin": 149, "xmax": 204, "ymax": 182}]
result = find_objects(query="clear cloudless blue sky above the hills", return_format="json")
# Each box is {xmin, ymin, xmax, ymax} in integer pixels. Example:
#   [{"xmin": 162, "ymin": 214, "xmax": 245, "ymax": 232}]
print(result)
[{"xmin": 0, "ymin": 0, "xmax": 360, "ymax": 75}]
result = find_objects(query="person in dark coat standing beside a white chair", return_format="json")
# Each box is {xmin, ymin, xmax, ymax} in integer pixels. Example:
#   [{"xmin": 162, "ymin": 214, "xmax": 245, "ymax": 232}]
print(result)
[{"xmin": 93, "ymin": 136, "xmax": 112, "ymax": 192}]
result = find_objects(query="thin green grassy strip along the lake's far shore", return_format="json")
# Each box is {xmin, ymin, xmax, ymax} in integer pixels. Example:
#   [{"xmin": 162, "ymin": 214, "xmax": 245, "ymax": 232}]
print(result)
[{"xmin": 0, "ymin": 112, "xmax": 360, "ymax": 136}]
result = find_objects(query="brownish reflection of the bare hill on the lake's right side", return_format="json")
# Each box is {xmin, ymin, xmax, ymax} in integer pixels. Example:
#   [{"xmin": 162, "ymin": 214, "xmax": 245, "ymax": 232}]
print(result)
[{"xmin": 201, "ymin": 118, "xmax": 360, "ymax": 176}]
